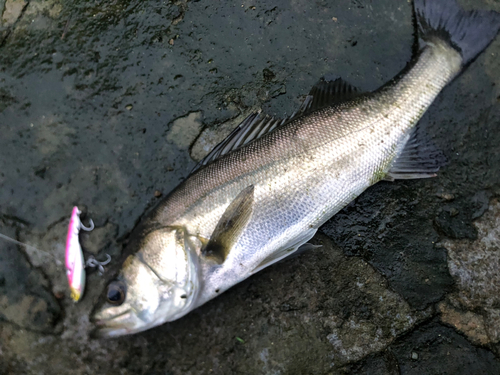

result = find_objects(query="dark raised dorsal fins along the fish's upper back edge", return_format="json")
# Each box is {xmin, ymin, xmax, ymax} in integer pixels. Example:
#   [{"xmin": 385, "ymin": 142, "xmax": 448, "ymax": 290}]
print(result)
[{"xmin": 191, "ymin": 78, "xmax": 360, "ymax": 173}]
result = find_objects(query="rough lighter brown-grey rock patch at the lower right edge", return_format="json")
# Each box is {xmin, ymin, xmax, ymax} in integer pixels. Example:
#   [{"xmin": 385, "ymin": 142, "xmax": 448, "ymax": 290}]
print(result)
[{"xmin": 440, "ymin": 199, "xmax": 500, "ymax": 345}]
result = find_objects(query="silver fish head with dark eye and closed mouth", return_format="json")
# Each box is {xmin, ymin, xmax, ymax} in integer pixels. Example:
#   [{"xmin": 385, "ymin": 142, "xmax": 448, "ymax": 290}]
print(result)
[{"xmin": 92, "ymin": 227, "xmax": 199, "ymax": 337}]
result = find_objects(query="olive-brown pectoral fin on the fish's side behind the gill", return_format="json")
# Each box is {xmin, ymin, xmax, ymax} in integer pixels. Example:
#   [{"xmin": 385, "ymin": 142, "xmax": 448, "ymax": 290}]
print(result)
[{"xmin": 201, "ymin": 185, "xmax": 254, "ymax": 264}]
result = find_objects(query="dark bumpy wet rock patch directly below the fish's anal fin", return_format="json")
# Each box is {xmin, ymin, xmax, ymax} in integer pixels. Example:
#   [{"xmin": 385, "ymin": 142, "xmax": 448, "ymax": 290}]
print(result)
[{"xmin": 320, "ymin": 181, "xmax": 453, "ymax": 309}]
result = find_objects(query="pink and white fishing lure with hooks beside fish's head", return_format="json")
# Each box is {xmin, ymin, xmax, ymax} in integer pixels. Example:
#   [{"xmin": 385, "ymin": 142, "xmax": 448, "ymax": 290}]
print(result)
[{"xmin": 66, "ymin": 206, "xmax": 94, "ymax": 302}]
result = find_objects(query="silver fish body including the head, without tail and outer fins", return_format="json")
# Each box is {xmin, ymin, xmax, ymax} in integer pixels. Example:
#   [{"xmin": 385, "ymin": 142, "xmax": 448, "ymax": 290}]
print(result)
[{"xmin": 95, "ymin": 0, "xmax": 500, "ymax": 336}]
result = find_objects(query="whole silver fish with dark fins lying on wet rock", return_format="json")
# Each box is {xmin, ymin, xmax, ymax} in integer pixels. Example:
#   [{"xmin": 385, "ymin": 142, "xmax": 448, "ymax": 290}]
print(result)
[{"xmin": 91, "ymin": 0, "xmax": 500, "ymax": 337}]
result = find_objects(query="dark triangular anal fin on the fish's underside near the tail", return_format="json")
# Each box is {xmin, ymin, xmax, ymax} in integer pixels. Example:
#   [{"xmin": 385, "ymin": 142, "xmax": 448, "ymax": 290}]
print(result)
[{"xmin": 384, "ymin": 125, "xmax": 446, "ymax": 181}]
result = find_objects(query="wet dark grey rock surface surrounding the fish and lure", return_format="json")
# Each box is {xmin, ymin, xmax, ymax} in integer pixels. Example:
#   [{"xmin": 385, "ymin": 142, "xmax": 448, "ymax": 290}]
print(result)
[{"xmin": 0, "ymin": 0, "xmax": 500, "ymax": 374}]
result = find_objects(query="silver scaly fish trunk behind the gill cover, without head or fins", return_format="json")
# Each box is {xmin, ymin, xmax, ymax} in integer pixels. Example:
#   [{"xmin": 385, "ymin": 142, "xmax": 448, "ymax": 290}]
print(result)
[{"xmin": 176, "ymin": 40, "xmax": 461, "ymax": 305}]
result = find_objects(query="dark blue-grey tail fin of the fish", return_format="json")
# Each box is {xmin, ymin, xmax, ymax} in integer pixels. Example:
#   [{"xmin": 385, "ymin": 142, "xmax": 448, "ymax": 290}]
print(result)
[{"xmin": 414, "ymin": 0, "xmax": 500, "ymax": 65}]
